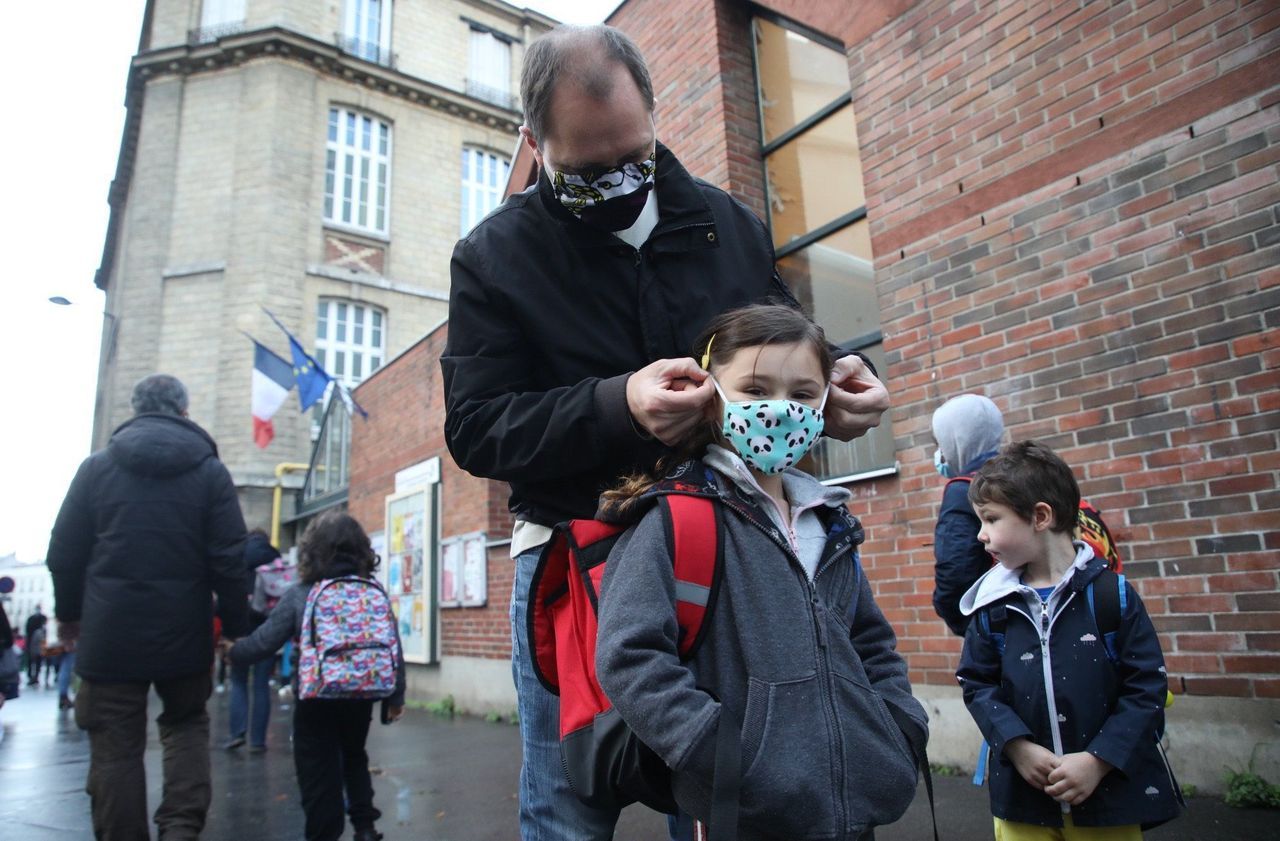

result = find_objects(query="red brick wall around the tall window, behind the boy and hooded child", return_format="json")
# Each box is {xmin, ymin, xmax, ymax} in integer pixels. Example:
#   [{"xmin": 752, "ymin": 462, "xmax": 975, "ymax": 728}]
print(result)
[{"xmin": 609, "ymin": 0, "xmax": 1280, "ymax": 698}]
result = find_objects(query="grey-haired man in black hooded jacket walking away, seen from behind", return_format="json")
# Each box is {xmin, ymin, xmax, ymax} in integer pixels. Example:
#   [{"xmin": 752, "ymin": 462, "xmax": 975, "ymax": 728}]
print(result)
[{"xmin": 47, "ymin": 374, "xmax": 248, "ymax": 841}]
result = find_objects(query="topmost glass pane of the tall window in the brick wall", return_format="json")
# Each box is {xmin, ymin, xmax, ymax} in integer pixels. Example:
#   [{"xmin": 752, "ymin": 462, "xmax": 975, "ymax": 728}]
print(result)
[{"xmin": 754, "ymin": 18, "xmax": 850, "ymax": 143}]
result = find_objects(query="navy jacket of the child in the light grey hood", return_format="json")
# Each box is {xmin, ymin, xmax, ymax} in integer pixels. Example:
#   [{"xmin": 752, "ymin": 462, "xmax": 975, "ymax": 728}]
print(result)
[{"xmin": 933, "ymin": 481, "xmax": 991, "ymax": 636}]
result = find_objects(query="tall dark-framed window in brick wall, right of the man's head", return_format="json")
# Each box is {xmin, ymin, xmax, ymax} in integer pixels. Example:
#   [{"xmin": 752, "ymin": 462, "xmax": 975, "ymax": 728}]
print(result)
[{"xmin": 751, "ymin": 17, "xmax": 895, "ymax": 480}]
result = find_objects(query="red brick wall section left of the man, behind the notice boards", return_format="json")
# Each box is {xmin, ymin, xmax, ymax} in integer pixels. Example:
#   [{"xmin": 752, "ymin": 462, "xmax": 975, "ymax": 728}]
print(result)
[{"xmin": 347, "ymin": 326, "xmax": 513, "ymax": 659}]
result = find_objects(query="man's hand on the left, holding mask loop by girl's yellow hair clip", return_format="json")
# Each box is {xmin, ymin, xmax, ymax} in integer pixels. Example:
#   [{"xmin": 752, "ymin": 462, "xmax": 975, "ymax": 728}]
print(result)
[{"xmin": 627, "ymin": 358, "xmax": 716, "ymax": 447}]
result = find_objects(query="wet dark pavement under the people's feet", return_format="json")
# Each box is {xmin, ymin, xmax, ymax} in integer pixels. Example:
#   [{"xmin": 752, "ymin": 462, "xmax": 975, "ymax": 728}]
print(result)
[{"xmin": 0, "ymin": 687, "xmax": 1280, "ymax": 841}]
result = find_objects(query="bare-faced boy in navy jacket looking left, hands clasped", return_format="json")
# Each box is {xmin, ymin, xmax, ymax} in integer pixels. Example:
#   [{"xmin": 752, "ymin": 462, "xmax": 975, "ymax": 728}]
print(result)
[{"xmin": 956, "ymin": 442, "xmax": 1181, "ymax": 841}]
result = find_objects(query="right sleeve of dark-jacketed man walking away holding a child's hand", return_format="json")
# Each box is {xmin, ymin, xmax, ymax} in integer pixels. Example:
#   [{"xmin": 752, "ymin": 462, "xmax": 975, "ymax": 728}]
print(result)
[{"xmin": 201, "ymin": 458, "xmax": 250, "ymax": 637}]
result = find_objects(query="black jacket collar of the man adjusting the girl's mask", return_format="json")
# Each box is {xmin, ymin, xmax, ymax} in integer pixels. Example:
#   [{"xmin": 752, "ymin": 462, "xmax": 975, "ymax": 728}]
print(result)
[{"xmin": 535, "ymin": 143, "xmax": 718, "ymax": 251}]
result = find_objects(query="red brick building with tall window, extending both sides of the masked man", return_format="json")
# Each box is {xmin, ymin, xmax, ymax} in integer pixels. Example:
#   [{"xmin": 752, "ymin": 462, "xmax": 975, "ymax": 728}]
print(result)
[{"xmin": 351, "ymin": 0, "xmax": 1280, "ymax": 790}]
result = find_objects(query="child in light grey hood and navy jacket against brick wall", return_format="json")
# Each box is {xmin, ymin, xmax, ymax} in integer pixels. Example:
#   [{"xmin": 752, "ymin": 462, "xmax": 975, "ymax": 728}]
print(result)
[{"xmin": 933, "ymin": 394, "xmax": 1005, "ymax": 636}]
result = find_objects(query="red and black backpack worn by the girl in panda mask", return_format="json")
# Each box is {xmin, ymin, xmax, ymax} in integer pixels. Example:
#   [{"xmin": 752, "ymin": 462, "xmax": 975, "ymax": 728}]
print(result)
[{"xmin": 529, "ymin": 494, "xmax": 723, "ymax": 814}]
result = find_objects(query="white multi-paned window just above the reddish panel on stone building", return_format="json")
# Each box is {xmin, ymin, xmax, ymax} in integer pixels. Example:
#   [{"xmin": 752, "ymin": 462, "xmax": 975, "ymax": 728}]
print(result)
[{"xmin": 323, "ymin": 104, "xmax": 396, "ymax": 238}]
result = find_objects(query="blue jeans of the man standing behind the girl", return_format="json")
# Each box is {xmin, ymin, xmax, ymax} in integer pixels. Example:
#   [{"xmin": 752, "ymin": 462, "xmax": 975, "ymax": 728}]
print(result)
[{"xmin": 511, "ymin": 548, "xmax": 618, "ymax": 841}]
